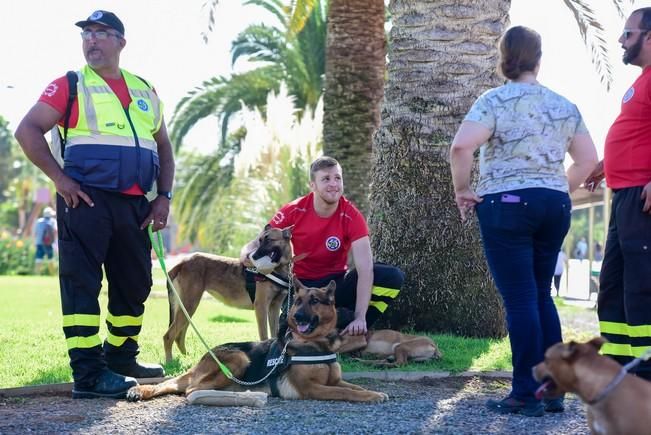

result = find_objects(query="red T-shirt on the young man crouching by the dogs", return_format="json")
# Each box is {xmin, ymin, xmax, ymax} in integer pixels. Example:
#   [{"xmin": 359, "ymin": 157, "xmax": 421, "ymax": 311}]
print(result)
[{"xmin": 269, "ymin": 193, "xmax": 368, "ymax": 279}]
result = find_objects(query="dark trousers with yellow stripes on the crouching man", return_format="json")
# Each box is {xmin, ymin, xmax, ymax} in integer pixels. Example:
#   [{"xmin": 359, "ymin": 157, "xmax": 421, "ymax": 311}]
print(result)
[{"xmin": 302, "ymin": 263, "xmax": 405, "ymax": 328}]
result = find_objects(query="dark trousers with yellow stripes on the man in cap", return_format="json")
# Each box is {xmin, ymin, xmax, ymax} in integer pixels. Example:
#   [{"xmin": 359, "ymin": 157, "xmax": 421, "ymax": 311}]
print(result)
[{"xmin": 57, "ymin": 187, "xmax": 152, "ymax": 387}]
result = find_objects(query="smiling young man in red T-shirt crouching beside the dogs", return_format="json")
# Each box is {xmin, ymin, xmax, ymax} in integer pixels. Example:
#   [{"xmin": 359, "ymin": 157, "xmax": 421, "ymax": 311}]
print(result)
[{"xmin": 240, "ymin": 156, "xmax": 404, "ymax": 335}]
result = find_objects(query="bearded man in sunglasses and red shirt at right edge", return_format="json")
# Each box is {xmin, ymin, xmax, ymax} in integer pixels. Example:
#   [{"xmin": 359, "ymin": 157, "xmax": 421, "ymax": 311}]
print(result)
[{"xmin": 586, "ymin": 8, "xmax": 651, "ymax": 380}]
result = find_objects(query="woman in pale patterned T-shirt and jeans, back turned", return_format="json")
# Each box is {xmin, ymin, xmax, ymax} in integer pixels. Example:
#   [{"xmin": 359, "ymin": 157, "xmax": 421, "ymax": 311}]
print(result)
[{"xmin": 450, "ymin": 26, "xmax": 597, "ymax": 416}]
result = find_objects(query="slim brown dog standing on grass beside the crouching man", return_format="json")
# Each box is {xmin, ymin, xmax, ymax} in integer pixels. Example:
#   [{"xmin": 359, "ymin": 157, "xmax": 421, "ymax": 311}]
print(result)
[{"xmin": 163, "ymin": 225, "xmax": 293, "ymax": 362}]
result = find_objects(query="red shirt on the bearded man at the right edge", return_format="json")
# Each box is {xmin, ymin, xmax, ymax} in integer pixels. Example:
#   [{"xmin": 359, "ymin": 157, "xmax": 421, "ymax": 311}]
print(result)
[{"xmin": 604, "ymin": 67, "xmax": 651, "ymax": 189}]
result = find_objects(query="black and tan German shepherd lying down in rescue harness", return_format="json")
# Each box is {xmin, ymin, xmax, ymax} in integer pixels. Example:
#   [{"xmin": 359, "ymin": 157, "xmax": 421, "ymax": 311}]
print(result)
[{"xmin": 127, "ymin": 279, "xmax": 388, "ymax": 402}]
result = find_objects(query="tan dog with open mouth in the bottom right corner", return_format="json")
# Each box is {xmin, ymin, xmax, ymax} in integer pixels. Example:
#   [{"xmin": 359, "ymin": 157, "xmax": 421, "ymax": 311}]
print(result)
[{"xmin": 533, "ymin": 337, "xmax": 651, "ymax": 435}]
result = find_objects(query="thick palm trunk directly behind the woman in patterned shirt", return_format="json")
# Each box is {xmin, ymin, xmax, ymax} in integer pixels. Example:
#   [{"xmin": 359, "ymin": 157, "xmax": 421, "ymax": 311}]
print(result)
[{"xmin": 370, "ymin": 0, "xmax": 510, "ymax": 337}]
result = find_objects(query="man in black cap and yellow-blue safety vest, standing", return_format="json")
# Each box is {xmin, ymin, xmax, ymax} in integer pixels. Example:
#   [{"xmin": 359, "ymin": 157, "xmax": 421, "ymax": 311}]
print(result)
[{"xmin": 16, "ymin": 11, "xmax": 174, "ymax": 399}]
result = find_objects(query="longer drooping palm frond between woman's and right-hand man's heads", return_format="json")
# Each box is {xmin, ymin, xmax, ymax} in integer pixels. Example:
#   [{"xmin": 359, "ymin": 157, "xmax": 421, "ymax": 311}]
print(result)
[{"xmin": 563, "ymin": 0, "xmax": 613, "ymax": 90}]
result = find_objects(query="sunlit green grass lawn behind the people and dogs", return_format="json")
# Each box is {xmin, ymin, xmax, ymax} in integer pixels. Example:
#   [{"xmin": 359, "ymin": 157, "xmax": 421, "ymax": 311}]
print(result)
[{"xmin": 0, "ymin": 269, "xmax": 511, "ymax": 388}]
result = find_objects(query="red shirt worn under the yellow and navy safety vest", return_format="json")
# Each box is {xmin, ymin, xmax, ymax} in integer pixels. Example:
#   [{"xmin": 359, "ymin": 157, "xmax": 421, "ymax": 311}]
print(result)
[{"xmin": 38, "ymin": 76, "xmax": 145, "ymax": 195}]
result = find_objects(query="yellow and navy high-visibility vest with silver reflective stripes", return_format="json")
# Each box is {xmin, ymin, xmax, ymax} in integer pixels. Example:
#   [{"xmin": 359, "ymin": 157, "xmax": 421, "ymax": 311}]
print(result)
[{"xmin": 59, "ymin": 65, "xmax": 163, "ymax": 191}]
